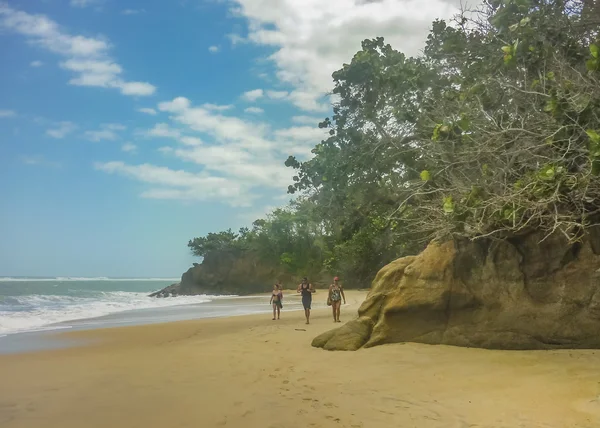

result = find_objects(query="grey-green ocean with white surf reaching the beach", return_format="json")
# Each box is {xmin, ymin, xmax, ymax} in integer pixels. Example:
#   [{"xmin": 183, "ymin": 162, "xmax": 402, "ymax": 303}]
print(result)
[{"xmin": 0, "ymin": 277, "xmax": 301, "ymax": 344}]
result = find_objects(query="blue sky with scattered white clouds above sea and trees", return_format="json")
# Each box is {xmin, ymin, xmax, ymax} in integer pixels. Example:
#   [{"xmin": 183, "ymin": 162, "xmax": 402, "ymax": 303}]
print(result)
[{"xmin": 0, "ymin": 0, "xmax": 460, "ymax": 277}]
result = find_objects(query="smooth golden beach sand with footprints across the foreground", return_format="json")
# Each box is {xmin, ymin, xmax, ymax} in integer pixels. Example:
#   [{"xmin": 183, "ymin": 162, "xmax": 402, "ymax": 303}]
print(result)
[{"xmin": 0, "ymin": 292, "xmax": 600, "ymax": 428}]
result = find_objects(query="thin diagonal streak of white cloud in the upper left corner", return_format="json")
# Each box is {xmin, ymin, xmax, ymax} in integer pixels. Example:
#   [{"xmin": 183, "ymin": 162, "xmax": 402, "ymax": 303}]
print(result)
[{"xmin": 0, "ymin": 0, "xmax": 156, "ymax": 96}]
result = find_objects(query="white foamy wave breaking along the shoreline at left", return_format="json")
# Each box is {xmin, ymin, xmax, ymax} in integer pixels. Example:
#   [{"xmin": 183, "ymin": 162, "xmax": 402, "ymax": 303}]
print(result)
[{"xmin": 0, "ymin": 291, "xmax": 213, "ymax": 335}]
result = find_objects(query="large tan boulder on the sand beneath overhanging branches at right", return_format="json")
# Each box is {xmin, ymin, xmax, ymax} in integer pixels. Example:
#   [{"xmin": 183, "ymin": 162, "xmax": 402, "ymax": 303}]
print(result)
[{"xmin": 313, "ymin": 229, "xmax": 600, "ymax": 350}]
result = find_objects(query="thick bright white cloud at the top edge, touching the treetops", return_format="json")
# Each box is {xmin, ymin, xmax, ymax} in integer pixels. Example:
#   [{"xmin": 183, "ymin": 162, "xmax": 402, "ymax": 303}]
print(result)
[{"xmin": 232, "ymin": 0, "xmax": 464, "ymax": 112}]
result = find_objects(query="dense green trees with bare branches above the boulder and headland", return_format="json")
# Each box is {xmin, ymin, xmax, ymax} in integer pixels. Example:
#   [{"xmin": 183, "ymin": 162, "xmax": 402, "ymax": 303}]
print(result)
[{"xmin": 189, "ymin": 0, "xmax": 600, "ymax": 285}]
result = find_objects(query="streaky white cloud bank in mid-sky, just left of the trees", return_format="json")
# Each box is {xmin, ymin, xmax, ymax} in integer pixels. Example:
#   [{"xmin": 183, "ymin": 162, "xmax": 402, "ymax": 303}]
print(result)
[{"xmin": 102, "ymin": 97, "xmax": 320, "ymax": 205}]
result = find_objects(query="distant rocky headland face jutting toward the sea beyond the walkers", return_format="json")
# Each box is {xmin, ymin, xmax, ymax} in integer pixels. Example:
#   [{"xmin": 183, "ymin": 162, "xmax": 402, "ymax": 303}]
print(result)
[{"xmin": 151, "ymin": 251, "xmax": 318, "ymax": 297}]
